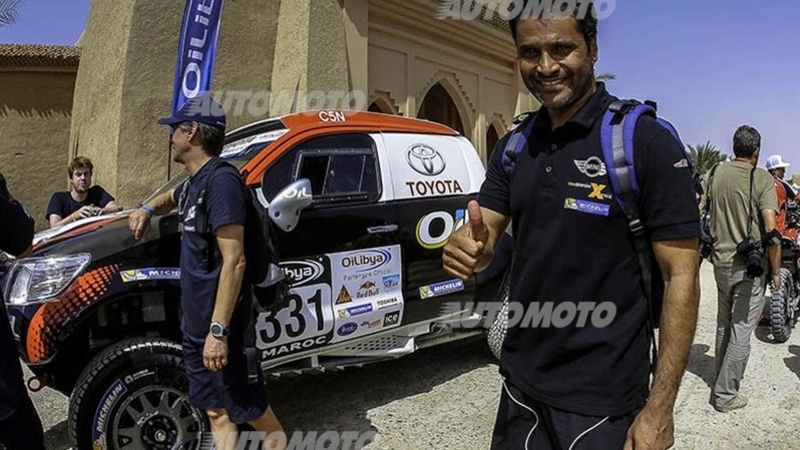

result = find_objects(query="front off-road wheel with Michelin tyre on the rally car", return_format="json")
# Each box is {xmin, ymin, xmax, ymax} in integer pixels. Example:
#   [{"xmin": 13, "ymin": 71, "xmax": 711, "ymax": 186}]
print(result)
[{"xmin": 69, "ymin": 338, "xmax": 209, "ymax": 450}]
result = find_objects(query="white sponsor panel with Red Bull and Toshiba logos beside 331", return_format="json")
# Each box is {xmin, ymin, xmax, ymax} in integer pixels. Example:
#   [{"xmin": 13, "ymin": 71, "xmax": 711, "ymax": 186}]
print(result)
[{"xmin": 329, "ymin": 245, "xmax": 403, "ymax": 343}]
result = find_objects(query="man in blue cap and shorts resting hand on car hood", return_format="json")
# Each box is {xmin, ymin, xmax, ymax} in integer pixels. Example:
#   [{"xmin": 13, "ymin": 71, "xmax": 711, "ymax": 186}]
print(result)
[{"xmin": 129, "ymin": 94, "xmax": 285, "ymax": 450}]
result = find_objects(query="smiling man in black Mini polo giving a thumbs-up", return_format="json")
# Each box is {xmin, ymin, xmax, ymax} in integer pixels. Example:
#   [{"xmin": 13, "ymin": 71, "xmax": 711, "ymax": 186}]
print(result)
[{"xmin": 443, "ymin": 1, "xmax": 699, "ymax": 450}]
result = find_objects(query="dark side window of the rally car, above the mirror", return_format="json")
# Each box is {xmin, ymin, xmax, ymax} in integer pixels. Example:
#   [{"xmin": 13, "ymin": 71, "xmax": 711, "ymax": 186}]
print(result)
[{"xmin": 264, "ymin": 134, "xmax": 380, "ymax": 204}]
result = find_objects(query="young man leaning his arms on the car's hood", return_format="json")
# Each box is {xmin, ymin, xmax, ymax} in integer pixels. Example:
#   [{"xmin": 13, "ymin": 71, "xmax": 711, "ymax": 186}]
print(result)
[{"xmin": 45, "ymin": 156, "xmax": 121, "ymax": 227}]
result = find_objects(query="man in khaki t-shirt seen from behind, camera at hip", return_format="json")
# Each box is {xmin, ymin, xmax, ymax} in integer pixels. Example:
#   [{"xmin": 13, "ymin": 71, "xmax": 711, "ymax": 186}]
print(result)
[{"xmin": 707, "ymin": 125, "xmax": 780, "ymax": 413}]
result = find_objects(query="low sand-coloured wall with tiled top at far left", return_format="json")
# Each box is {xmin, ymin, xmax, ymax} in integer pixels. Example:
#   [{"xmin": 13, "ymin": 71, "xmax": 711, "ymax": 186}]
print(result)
[{"xmin": 0, "ymin": 45, "xmax": 80, "ymax": 229}]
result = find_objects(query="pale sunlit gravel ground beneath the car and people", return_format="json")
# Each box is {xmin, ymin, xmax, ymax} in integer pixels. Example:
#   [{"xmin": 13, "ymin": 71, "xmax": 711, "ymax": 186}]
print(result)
[{"xmin": 28, "ymin": 263, "xmax": 800, "ymax": 450}]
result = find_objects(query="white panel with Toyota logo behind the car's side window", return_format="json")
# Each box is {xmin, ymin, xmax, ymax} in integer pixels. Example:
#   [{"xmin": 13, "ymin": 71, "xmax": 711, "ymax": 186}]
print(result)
[{"xmin": 384, "ymin": 134, "xmax": 474, "ymax": 199}]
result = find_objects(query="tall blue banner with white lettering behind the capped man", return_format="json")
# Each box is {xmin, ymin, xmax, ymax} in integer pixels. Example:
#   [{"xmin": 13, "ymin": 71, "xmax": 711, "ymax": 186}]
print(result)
[{"xmin": 172, "ymin": 0, "xmax": 223, "ymax": 114}]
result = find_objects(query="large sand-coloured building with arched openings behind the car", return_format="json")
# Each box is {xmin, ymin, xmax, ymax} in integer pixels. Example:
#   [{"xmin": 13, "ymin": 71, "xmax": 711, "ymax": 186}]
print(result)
[{"xmin": 0, "ymin": 0, "xmax": 536, "ymax": 222}]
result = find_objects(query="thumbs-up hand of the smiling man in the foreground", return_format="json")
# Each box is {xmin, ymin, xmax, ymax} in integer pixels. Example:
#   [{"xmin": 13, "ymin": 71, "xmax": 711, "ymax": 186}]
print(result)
[{"xmin": 442, "ymin": 200, "xmax": 492, "ymax": 280}]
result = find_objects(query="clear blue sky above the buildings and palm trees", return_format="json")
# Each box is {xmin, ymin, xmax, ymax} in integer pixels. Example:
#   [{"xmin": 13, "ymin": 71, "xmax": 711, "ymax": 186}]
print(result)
[{"xmin": 0, "ymin": 0, "xmax": 800, "ymax": 173}]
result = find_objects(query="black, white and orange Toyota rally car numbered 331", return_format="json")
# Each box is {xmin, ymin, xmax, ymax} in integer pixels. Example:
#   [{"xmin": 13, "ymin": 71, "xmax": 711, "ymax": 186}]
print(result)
[{"xmin": 4, "ymin": 111, "xmax": 506, "ymax": 450}]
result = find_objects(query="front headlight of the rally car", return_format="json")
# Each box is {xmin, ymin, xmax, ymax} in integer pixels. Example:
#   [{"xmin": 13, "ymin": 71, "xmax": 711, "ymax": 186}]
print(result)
[{"xmin": 4, "ymin": 253, "xmax": 92, "ymax": 306}]
